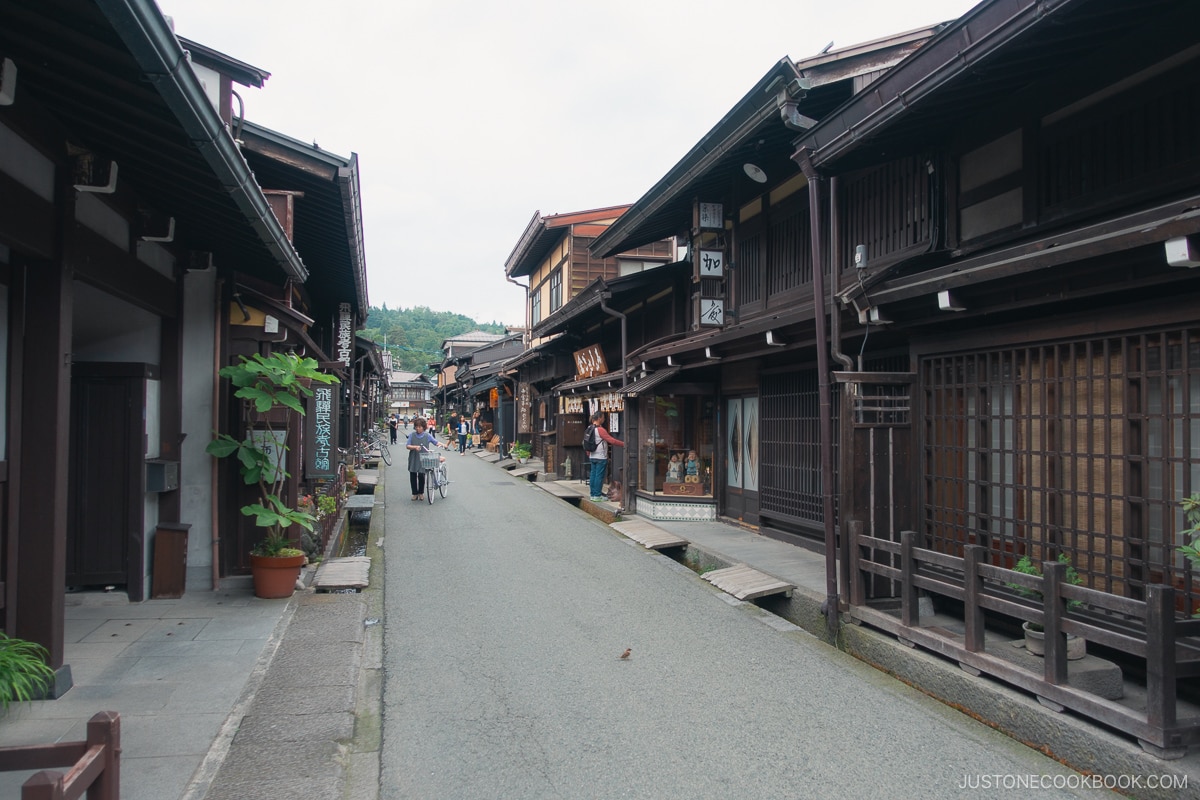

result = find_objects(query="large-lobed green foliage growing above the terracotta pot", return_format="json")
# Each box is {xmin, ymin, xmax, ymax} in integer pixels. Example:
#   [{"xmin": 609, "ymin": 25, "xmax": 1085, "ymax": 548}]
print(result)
[{"xmin": 206, "ymin": 353, "xmax": 337, "ymax": 555}]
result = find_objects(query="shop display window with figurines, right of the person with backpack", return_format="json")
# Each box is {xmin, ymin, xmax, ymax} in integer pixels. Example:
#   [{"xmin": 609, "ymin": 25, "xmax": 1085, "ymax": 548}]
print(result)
[{"xmin": 638, "ymin": 395, "xmax": 714, "ymax": 498}]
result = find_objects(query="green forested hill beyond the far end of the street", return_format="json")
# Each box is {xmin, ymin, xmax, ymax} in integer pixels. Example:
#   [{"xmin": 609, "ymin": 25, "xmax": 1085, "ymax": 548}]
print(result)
[{"xmin": 361, "ymin": 306, "xmax": 504, "ymax": 374}]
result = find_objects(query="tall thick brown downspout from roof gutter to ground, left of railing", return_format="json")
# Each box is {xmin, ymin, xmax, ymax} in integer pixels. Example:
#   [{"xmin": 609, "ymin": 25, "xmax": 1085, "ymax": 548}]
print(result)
[{"xmin": 792, "ymin": 149, "xmax": 839, "ymax": 634}]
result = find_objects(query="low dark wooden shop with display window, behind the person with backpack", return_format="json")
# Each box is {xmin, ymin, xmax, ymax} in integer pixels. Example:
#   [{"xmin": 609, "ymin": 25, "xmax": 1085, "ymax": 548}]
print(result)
[{"xmin": 526, "ymin": 261, "xmax": 696, "ymax": 510}]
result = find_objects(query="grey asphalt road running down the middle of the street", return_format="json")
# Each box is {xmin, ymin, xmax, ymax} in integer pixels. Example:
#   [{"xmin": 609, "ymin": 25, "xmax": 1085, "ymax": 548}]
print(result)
[{"xmin": 380, "ymin": 453, "xmax": 1115, "ymax": 800}]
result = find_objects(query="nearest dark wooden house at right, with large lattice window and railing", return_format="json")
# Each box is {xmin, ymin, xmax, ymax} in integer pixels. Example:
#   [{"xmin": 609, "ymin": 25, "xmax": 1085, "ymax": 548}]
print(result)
[{"xmin": 598, "ymin": 0, "xmax": 1200, "ymax": 758}]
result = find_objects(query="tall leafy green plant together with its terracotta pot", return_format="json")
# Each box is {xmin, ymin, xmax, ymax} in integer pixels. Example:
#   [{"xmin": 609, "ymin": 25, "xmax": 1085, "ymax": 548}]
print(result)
[{"xmin": 206, "ymin": 353, "xmax": 337, "ymax": 597}]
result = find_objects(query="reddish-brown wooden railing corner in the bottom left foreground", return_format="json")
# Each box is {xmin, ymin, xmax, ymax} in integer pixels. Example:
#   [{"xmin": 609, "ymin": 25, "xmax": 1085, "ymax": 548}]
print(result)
[{"xmin": 0, "ymin": 711, "xmax": 121, "ymax": 800}]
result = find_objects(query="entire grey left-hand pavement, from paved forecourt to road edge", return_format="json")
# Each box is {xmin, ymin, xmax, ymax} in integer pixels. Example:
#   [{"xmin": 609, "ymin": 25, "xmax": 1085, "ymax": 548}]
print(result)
[{"xmin": 0, "ymin": 493, "xmax": 385, "ymax": 800}]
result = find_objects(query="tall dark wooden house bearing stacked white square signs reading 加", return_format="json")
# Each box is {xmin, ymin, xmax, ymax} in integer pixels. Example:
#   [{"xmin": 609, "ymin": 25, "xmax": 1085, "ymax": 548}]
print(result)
[{"xmin": 592, "ymin": 28, "xmax": 936, "ymax": 537}]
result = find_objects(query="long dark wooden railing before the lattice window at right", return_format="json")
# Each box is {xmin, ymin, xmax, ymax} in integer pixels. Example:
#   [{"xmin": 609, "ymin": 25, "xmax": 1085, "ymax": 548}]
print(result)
[{"xmin": 850, "ymin": 523, "xmax": 1200, "ymax": 758}]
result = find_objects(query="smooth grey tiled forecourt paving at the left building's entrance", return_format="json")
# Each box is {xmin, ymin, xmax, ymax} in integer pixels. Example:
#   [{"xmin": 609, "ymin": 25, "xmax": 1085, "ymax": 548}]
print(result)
[{"xmin": 0, "ymin": 579, "xmax": 292, "ymax": 800}]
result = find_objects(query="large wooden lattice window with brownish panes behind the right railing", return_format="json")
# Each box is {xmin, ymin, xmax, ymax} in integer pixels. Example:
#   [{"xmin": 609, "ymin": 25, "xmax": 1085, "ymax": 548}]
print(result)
[{"xmin": 920, "ymin": 330, "xmax": 1200, "ymax": 602}]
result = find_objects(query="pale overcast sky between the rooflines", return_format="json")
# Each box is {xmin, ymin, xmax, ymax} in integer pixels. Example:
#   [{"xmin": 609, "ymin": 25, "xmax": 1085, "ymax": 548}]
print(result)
[{"xmin": 158, "ymin": 0, "xmax": 976, "ymax": 325}]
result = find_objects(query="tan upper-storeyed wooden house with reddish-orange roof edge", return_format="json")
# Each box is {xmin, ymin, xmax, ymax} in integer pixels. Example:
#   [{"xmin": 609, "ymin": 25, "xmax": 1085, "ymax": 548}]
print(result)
[{"xmin": 504, "ymin": 205, "xmax": 676, "ymax": 479}]
